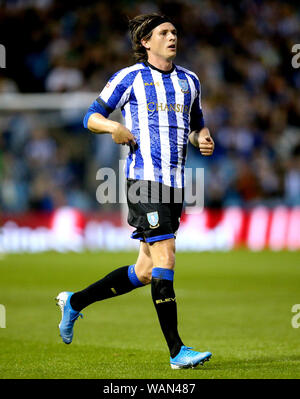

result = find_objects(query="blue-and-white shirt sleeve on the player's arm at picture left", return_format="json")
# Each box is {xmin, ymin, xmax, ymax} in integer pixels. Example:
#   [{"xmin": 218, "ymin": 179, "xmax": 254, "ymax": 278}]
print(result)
[{"xmin": 83, "ymin": 69, "xmax": 134, "ymax": 128}]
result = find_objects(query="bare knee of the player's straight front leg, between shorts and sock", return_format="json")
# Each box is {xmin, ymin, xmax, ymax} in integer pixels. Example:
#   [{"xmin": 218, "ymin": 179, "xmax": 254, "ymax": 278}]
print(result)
[{"xmin": 148, "ymin": 238, "xmax": 175, "ymax": 269}]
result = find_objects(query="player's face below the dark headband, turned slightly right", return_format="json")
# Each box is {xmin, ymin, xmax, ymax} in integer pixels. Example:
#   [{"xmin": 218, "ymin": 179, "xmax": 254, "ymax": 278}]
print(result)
[{"xmin": 142, "ymin": 22, "xmax": 177, "ymax": 60}]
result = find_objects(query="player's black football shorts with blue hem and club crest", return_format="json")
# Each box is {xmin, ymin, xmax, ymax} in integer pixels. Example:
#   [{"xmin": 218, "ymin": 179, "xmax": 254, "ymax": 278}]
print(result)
[{"xmin": 126, "ymin": 179, "xmax": 184, "ymax": 243}]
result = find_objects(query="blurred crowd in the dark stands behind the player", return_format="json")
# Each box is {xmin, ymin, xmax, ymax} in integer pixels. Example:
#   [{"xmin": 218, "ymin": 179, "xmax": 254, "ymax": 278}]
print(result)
[{"xmin": 0, "ymin": 0, "xmax": 300, "ymax": 212}]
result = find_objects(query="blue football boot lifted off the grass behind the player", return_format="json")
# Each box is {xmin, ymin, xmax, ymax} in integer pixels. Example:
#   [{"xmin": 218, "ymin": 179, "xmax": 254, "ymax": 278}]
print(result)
[{"xmin": 55, "ymin": 291, "xmax": 83, "ymax": 344}]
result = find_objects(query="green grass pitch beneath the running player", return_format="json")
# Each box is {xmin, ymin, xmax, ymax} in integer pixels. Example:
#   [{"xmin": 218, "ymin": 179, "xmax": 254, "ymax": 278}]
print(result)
[{"xmin": 0, "ymin": 250, "xmax": 300, "ymax": 379}]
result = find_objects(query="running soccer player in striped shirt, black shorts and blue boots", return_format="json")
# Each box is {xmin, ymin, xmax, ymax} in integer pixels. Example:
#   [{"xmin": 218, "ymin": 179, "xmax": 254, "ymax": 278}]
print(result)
[{"xmin": 56, "ymin": 14, "xmax": 214, "ymax": 369}]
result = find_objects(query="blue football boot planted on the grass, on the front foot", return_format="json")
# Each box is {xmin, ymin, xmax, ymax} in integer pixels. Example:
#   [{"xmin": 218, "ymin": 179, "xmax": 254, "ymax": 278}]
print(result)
[{"xmin": 170, "ymin": 345, "xmax": 212, "ymax": 369}]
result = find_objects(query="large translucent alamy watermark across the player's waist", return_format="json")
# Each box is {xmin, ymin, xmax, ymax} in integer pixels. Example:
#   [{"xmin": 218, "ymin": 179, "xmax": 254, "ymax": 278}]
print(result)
[{"xmin": 96, "ymin": 161, "xmax": 204, "ymax": 209}]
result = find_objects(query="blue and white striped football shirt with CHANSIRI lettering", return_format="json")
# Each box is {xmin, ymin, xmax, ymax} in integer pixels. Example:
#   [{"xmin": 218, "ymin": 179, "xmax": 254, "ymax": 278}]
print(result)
[{"xmin": 84, "ymin": 63, "xmax": 204, "ymax": 187}]
